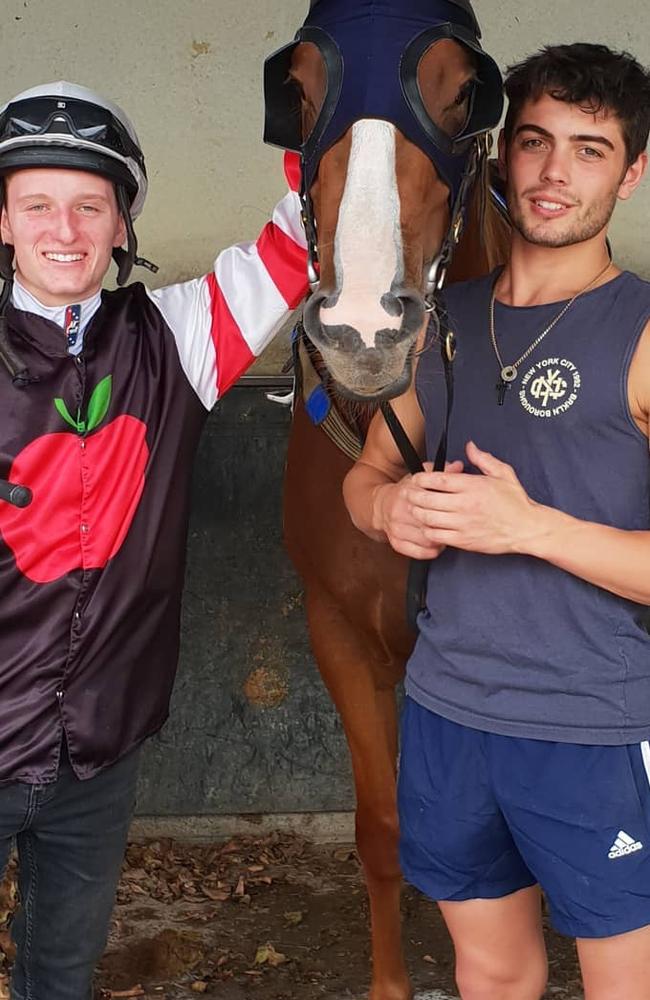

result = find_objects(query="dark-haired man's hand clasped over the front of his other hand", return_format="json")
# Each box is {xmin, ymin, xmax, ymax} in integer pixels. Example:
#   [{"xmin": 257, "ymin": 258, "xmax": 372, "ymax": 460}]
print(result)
[{"xmin": 403, "ymin": 441, "xmax": 544, "ymax": 555}]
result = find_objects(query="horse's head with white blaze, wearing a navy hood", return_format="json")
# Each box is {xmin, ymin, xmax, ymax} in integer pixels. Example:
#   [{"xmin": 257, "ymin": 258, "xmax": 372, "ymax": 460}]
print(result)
[{"xmin": 265, "ymin": 0, "xmax": 503, "ymax": 399}]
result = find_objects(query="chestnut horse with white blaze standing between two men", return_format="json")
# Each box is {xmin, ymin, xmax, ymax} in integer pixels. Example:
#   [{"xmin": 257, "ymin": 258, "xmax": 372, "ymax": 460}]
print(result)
[{"xmin": 266, "ymin": 0, "xmax": 508, "ymax": 1000}]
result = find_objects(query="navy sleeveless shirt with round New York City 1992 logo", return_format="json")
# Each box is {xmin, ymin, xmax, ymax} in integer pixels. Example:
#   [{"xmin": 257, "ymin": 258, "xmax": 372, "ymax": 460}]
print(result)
[{"xmin": 406, "ymin": 272, "xmax": 650, "ymax": 745}]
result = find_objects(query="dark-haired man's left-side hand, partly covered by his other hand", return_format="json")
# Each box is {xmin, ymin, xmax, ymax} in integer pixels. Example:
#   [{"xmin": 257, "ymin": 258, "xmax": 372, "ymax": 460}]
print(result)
[{"xmin": 376, "ymin": 462, "xmax": 463, "ymax": 559}]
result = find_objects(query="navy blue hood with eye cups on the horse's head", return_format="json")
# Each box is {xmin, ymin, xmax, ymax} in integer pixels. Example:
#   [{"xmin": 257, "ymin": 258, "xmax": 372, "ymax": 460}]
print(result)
[{"xmin": 264, "ymin": 0, "xmax": 503, "ymax": 208}]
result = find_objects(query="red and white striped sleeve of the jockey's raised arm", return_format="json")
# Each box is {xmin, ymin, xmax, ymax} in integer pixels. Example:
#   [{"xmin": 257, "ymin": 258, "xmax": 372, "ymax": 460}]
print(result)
[{"xmin": 148, "ymin": 153, "xmax": 308, "ymax": 409}]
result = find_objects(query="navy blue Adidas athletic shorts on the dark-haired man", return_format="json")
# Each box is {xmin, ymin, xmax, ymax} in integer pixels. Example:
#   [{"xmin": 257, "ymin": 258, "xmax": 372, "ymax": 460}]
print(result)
[{"xmin": 398, "ymin": 698, "xmax": 650, "ymax": 938}]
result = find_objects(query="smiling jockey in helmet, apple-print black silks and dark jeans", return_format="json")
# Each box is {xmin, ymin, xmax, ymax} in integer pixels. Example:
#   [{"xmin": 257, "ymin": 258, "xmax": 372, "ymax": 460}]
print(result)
[{"xmin": 0, "ymin": 83, "xmax": 306, "ymax": 1000}]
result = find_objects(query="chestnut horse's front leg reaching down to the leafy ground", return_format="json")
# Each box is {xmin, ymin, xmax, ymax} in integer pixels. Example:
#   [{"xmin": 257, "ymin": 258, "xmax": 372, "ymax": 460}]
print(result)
[{"xmin": 307, "ymin": 588, "xmax": 411, "ymax": 1000}]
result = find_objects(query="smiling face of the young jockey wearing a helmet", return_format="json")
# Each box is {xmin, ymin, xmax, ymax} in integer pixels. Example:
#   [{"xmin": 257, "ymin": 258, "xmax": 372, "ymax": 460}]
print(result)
[{"xmin": 1, "ymin": 167, "xmax": 126, "ymax": 306}]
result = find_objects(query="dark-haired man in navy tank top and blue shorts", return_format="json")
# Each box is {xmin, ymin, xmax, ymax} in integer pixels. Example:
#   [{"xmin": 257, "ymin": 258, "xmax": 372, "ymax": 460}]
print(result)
[{"xmin": 345, "ymin": 44, "xmax": 650, "ymax": 1000}]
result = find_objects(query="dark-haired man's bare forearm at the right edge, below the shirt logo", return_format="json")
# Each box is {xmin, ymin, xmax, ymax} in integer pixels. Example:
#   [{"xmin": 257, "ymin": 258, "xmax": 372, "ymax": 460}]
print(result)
[{"xmin": 520, "ymin": 507, "xmax": 650, "ymax": 605}]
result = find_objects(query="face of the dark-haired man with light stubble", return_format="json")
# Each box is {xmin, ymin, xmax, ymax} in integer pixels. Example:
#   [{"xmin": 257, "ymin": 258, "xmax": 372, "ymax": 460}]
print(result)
[{"xmin": 499, "ymin": 94, "xmax": 647, "ymax": 247}]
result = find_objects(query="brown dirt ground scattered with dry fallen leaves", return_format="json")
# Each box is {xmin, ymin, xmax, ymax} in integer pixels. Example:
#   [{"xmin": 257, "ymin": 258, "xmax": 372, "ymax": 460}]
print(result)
[{"xmin": 0, "ymin": 834, "xmax": 582, "ymax": 1000}]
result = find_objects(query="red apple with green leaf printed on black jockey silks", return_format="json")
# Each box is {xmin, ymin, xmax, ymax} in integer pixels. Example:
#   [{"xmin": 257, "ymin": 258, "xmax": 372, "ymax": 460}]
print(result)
[{"xmin": 0, "ymin": 375, "xmax": 149, "ymax": 583}]
